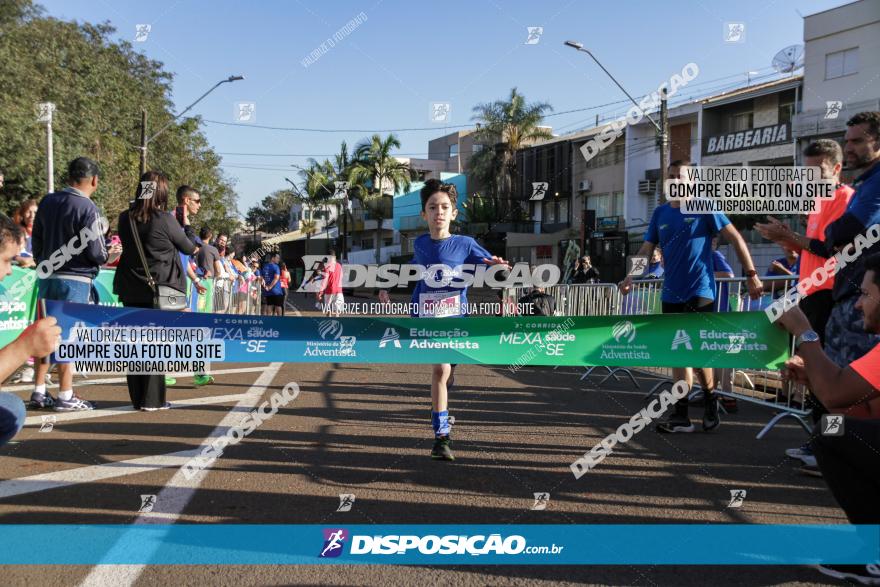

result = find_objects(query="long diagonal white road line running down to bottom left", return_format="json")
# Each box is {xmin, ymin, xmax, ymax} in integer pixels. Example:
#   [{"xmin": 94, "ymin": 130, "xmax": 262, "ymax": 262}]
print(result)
[{"xmin": 80, "ymin": 363, "xmax": 282, "ymax": 587}]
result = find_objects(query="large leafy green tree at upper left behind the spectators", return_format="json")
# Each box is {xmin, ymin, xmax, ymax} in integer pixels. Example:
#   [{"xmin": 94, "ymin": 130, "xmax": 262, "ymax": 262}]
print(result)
[{"xmin": 0, "ymin": 0, "xmax": 238, "ymax": 231}]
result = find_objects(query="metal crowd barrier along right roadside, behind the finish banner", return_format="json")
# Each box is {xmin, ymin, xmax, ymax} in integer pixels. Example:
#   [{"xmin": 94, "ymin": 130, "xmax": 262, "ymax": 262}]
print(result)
[{"xmin": 505, "ymin": 276, "xmax": 812, "ymax": 439}]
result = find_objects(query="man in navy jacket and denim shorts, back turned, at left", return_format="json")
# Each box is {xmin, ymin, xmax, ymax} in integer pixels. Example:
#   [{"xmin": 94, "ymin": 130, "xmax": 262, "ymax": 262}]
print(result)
[{"xmin": 31, "ymin": 157, "xmax": 107, "ymax": 412}]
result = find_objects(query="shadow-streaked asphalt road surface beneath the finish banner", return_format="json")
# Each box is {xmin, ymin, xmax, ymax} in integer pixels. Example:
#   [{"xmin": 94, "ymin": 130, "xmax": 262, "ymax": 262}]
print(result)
[{"xmin": 0, "ymin": 296, "xmax": 846, "ymax": 586}]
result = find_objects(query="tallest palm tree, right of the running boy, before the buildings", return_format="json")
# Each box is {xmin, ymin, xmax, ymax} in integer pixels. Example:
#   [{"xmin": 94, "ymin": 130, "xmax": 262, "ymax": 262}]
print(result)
[{"xmin": 469, "ymin": 88, "xmax": 553, "ymax": 215}]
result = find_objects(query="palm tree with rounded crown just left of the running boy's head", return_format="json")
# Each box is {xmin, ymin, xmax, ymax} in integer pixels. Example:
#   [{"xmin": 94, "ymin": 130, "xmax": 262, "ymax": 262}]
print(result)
[{"xmin": 348, "ymin": 134, "xmax": 412, "ymax": 263}]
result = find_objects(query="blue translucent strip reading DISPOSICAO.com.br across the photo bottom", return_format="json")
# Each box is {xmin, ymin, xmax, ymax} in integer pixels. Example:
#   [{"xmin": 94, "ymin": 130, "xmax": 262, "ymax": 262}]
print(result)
[{"xmin": 0, "ymin": 524, "xmax": 880, "ymax": 565}]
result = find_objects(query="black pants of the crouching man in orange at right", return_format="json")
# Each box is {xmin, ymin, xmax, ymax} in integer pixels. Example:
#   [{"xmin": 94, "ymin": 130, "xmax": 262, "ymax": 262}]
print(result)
[{"xmin": 812, "ymin": 418, "xmax": 880, "ymax": 524}]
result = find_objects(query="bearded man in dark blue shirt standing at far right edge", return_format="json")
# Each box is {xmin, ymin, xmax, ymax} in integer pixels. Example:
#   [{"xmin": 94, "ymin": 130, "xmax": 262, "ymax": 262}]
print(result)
[{"xmin": 810, "ymin": 112, "xmax": 880, "ymax": 365}]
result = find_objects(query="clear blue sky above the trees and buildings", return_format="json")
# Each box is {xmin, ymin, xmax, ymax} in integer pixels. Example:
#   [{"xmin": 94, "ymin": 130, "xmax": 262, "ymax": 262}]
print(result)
[{"xmin": 41, "ymin": 0, "xmax": 846, "ymax": 214}]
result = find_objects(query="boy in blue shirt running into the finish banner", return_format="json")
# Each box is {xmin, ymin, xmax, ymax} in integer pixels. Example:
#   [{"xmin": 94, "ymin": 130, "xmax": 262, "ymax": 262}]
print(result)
[{"xmin": 379, "ymin": 179, "xmax": 508, "ymax": 461}]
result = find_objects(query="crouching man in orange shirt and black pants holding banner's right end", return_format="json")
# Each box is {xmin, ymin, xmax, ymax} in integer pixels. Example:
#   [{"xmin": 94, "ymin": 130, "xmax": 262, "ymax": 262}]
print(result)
[{"xmin": 778, "ymin": 253, "xmax": 880, "ymax": 585}]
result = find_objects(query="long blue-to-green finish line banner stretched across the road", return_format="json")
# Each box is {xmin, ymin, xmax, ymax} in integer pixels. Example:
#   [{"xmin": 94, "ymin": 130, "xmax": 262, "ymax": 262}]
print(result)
[{"xmin": 45, "ymin": 300, "xmax": 789, "ymax": 373}]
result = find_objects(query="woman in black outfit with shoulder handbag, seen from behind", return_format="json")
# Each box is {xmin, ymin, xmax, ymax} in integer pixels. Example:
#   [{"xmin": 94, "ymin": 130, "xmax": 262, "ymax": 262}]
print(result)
[{"xmin": 113, "ymin": 171, "xmax": 195, "ymax": 412}]
